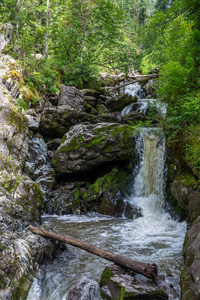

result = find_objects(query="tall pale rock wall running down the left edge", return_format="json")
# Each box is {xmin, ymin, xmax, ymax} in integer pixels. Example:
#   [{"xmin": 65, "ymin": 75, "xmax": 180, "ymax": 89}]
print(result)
[{"xmin": 0, "ymin": 55, "xmax": 62, "ymax": 300}]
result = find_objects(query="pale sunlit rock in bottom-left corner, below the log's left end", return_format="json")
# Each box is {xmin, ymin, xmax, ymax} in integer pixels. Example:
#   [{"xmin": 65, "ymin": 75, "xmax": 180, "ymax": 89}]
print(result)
[{"xmin": 0, "ymin": 232, "xmax": 55, "ymax": 300}]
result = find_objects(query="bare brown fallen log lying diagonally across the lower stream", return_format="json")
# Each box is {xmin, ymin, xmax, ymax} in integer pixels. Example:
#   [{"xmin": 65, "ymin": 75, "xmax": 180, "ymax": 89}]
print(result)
[{"xmin": 29, "ymin": 226, "xmax": 158, "ymax": 279}]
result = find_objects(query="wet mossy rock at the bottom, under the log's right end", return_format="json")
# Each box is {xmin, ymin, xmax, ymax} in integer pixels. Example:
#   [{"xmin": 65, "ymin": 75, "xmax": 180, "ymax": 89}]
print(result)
[{"xmin": 100, "ymin": 264, "xmax": 168, "ymax": 300}]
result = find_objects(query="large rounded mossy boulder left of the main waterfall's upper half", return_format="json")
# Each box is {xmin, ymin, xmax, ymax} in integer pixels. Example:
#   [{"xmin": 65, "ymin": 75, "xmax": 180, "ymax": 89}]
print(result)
[{"xmin": 52, "ymin": 123, "xmax": 135, "ymax": 174}]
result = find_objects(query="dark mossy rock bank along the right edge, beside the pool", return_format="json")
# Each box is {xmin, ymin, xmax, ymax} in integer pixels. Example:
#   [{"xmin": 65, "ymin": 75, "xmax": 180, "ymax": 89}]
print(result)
[{"xmin": 166, "ymin": 156, "xmax": 200, "ymax": 300}]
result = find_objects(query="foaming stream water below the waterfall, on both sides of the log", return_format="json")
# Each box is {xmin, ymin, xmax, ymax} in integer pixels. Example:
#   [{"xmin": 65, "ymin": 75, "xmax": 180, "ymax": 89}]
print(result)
[{"xmin": 27, "ymin": 213, "xmax": 185, "ymax": 300}]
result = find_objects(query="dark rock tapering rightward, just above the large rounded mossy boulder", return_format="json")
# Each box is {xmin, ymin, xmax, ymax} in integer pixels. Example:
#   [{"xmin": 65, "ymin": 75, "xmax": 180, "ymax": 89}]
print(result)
[{"xmin": 39, "ymin": 105, "xmax": 122, "ymax": 139}]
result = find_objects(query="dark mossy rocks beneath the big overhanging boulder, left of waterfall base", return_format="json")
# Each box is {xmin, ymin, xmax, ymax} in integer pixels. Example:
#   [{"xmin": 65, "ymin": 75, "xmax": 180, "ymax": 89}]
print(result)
[{"xmin": 45, "ymin": 168, "xmax": 133, "ymax": 219}]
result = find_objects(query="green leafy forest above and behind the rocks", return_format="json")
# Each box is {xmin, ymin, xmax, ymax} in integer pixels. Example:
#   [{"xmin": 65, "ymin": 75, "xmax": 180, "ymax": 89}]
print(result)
[{"xmin": 0, "ymin": 0, "xmax": 200, "ymax": 173}]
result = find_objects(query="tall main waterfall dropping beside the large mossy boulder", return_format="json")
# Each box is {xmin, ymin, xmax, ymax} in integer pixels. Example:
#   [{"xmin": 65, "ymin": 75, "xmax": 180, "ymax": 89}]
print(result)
[{"xmin": 133, "ymin": 128, "xmax": 165, "ymax": 210}]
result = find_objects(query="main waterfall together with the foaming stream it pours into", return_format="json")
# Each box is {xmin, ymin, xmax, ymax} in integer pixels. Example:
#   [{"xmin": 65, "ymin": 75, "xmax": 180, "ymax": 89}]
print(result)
[{"xmin": 27, "ymin": 84, "xmax": 186, "ymax": 300}]
